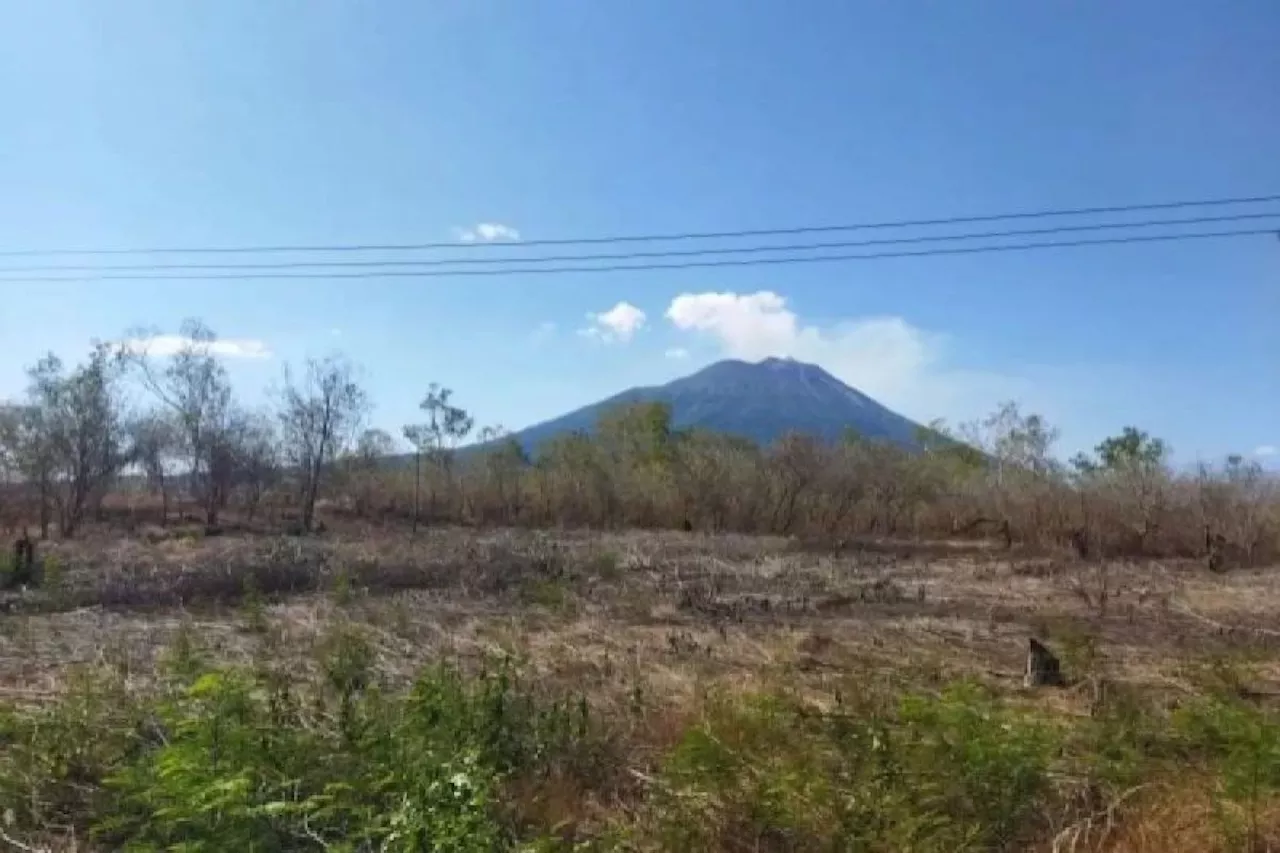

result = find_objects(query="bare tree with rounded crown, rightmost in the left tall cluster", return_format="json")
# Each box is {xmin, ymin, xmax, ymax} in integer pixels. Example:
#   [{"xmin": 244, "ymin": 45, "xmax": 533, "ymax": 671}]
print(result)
[{"xmin": 279, "ymin": 356, "xmax": 369, "ymax": 530}]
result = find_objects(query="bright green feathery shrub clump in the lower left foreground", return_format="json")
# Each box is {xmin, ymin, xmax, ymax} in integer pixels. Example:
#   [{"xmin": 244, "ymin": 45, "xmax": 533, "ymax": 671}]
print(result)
[{"xmin": 13, "ymin": 648, "xmax": 600, "ymax": 853}]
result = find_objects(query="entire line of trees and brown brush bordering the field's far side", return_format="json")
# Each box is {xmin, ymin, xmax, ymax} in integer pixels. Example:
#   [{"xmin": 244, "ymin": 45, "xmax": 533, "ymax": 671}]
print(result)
[{"xmin": 0, "ymin": 321, "xmax": 1280, "ymax": 564}]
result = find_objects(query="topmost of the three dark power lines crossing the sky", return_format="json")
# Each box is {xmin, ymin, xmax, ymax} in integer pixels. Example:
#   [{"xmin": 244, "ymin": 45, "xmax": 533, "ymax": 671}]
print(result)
[{"xmin": 0, "ymin": 195, "xmax": 1280, "ymax": 257}]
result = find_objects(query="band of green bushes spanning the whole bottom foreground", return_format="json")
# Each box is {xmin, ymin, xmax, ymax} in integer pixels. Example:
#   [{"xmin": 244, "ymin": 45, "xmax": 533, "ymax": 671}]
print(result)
[{"xmin": 0, "ymin": 640, "xmax": 1280, "ymax": 853}]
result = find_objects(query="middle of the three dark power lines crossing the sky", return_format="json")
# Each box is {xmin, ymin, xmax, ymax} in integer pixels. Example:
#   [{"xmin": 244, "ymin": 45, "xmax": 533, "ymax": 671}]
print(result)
[{"xmin": 0, "ymin": 210, "xmax": 1280, "ymax": 270}]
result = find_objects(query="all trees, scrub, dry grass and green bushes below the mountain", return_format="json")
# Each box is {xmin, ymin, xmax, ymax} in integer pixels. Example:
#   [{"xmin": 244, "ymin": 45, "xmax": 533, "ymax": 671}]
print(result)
[{"xmin": 0, "ymin": 322, "xmax": 1280, "ymax": 853}]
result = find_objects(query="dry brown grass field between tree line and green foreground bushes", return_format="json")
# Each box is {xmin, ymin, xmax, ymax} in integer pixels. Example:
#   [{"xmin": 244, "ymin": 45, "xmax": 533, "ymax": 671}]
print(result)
[{"xmin": 0, "ymin": 528, "xmax": 1280, "ymax": 852}]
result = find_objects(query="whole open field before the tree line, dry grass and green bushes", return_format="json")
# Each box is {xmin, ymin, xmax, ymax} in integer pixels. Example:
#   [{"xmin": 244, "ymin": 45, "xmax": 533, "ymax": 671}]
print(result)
[{"xmin": 0, "ymin": 525, "xmax": 1280, "ymax": 850}]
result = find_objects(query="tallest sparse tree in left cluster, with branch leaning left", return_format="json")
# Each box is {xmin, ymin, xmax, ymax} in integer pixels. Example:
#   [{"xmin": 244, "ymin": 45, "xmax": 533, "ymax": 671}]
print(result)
[{"xmin": 127, "ymin": 320, "xmax": 233, "ymax": 525}]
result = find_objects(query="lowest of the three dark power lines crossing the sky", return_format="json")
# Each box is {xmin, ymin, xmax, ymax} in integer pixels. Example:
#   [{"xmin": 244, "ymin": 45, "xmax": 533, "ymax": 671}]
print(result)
[{"xmin": 0, "ymin": 228, "xmax": 1276, "ymax": 283}]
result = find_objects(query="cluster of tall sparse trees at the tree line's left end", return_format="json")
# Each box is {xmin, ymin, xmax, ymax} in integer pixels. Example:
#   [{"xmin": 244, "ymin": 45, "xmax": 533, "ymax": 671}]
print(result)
[{"xmin": 0, "ymin": 320, "xmax": 370, "ymax": 537}]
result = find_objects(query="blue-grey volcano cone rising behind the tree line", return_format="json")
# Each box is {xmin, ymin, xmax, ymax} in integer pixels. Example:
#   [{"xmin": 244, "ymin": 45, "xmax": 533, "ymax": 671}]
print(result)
[{"xmin": 499, "ymin": 359, "xmax": 919, "ymax": 452}]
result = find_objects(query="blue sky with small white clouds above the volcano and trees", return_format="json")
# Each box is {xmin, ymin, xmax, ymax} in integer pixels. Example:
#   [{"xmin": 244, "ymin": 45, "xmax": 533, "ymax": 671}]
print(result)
[{"xmin": 0, "ymin": 0, "xmax": 1280, "ymax": 459}]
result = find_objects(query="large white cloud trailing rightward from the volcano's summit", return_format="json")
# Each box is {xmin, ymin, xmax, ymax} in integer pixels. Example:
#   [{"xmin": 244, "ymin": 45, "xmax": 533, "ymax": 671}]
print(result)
[{"xmin": 666, "ymin": 291, "xmax": 1034, "ymax": 421}]
